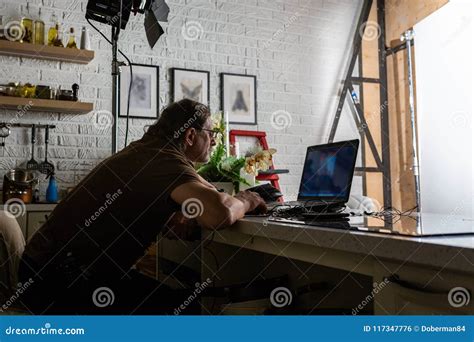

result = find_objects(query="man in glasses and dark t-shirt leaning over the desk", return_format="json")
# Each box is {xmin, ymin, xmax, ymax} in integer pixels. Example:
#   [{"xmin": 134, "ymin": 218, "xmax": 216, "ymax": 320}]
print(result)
[{"xmin": 19, "ymin": 100, "xmax": 266, "ymax": 314}]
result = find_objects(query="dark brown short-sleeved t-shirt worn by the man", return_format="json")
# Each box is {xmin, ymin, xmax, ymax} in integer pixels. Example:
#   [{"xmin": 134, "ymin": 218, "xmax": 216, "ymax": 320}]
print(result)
[{"xmin": 25, "ymin": 138, "xmax": 199, "ymax": 277}]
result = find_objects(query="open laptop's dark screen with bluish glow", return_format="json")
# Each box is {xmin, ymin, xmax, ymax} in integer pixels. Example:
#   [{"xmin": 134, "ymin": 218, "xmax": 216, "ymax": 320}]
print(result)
[{"xmin": 298, "ymin": 140, "xmax": 359, "ymax": 202}]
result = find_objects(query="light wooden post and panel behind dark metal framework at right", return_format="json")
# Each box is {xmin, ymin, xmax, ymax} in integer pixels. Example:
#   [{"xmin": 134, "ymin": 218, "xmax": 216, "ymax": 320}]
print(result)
[{"xmin": 385, "ymin": 0, "xmax": 448, "ymax": 210}]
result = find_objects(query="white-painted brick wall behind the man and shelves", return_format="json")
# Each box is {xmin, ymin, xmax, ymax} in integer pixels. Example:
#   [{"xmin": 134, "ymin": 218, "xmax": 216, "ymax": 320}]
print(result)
[{"xmin": 0, "ymin": 0, "xmax": 360, "ymax": 199}]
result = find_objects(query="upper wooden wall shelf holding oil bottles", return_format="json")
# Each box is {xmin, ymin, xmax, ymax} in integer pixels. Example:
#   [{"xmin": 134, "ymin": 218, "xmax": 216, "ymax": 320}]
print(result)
[{"xmin": 0, "ymin": 40, "xmax": 94, "ymax": 64}]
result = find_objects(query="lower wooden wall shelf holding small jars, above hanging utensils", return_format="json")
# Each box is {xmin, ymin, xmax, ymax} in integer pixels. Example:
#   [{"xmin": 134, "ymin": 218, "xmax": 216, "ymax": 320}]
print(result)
[{"xmin": 0, "ymin": 96, "xmax": 94, "ymax": 114}]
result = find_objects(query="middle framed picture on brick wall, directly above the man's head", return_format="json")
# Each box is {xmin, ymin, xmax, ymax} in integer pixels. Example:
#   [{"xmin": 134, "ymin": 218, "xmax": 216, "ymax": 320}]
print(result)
[{"xmin": 171, "ymin": 68, "xmax": 210, "ymax": 106}]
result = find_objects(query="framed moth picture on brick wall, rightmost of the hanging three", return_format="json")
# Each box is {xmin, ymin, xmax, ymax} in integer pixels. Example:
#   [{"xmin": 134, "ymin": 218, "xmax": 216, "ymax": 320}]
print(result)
[{"xmin": 221, "ymin": 73, "xmax": 257, "ymax": 125}]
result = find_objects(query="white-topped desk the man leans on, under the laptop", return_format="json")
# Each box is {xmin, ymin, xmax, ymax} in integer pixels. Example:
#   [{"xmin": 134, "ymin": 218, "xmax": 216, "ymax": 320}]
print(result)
[{"xmin": 202, "ymin": 218, "xmax": 474, "ymax": 314}]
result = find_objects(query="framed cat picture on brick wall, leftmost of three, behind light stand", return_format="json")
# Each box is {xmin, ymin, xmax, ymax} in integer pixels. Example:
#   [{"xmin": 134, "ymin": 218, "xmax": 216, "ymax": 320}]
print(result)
[{"xmin": 119, "ymin": 63, "xmax": 160, "ymax": 119}]
